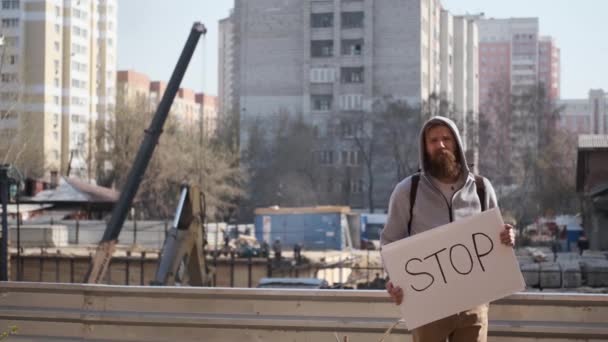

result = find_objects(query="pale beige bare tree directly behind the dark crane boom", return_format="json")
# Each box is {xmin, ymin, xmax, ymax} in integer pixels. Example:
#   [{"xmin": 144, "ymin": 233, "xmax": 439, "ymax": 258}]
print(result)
[{"xmin": 96, "ymin": 98, "xmax": 242, "ymax": 218}]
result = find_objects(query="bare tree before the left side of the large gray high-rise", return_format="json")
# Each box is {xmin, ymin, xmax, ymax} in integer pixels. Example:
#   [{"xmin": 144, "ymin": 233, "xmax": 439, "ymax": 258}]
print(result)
[{"xmin": 241, "ymin": 111, "xmax": 321, "ymax": 218}]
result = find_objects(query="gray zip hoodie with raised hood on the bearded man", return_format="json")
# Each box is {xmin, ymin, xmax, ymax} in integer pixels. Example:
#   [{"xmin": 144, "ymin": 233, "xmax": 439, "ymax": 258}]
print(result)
[{"xmin": 380, "ymin": 116, "xmax": 498, "ymax": 245}]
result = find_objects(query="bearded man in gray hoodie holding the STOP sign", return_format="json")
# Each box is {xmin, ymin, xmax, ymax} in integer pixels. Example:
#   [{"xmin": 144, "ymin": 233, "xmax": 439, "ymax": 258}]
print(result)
[{"xmin": 380, "ymin": 116, "xmax": 515, "ymax": 342}]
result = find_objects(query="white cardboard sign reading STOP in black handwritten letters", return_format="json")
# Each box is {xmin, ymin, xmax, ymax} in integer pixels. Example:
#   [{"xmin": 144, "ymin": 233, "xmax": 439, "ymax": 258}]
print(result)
[{"xmin": 381, "ymin": 208, "xmax": 525, "ymax": 329}]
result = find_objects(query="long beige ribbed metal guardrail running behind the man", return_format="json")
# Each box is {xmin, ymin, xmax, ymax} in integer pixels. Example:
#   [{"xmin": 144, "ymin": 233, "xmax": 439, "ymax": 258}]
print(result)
[{"xmin": 0, "ymin": 282, "xmax": 608, "ymax": 342}]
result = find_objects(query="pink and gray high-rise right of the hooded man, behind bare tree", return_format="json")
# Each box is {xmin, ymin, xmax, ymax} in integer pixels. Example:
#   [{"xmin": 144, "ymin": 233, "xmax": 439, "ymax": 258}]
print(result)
[{"xmin": 477, "ymin": 15, "xmax": 560, "ymax": 185}]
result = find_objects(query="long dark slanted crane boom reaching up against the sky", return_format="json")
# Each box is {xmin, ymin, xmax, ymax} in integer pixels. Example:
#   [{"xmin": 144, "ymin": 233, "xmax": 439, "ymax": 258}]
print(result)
[{"xmin": 85, "ymin": 22, "xmax": 207, "ymax": 284}]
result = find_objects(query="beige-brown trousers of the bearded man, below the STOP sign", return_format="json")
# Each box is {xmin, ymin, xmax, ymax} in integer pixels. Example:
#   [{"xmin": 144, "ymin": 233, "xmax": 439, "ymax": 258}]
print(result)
[{"xmin": 412, "ymin": 304, "xmax": 488, "ymax": 342}]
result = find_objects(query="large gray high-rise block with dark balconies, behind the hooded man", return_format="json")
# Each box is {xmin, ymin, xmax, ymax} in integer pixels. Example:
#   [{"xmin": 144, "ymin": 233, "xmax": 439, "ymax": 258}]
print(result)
[{"xmin": 230, "ymin": 0, "xmax": 477, "ymax": 206}]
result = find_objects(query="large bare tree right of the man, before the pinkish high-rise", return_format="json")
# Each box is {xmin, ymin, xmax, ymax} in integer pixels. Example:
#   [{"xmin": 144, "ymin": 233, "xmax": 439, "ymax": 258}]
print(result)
[{"xmin": 480, "ymin": 84, "xmax": 577, "ymax": 225}]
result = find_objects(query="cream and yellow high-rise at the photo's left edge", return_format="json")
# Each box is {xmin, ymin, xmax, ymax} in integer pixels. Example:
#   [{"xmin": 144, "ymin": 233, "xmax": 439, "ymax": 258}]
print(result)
[{"xmin": 0, "ymin": 0, "xmax": 117, "ymax": 181}]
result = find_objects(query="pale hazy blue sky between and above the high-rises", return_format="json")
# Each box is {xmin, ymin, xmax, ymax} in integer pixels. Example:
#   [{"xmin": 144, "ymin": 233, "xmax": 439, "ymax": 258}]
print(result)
[{"xmin": 118, "ymin": 0, "xmax": 608, "ymax": 99}]
